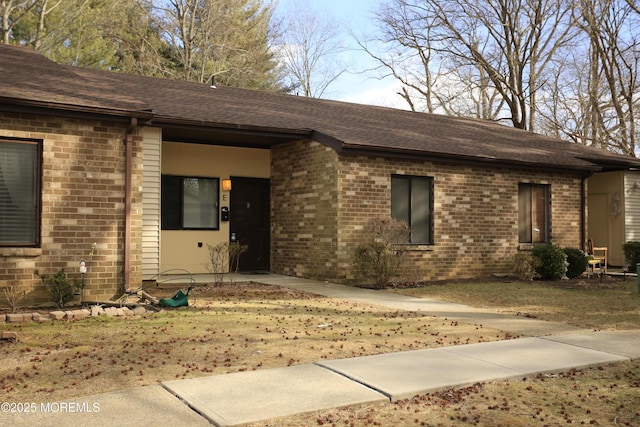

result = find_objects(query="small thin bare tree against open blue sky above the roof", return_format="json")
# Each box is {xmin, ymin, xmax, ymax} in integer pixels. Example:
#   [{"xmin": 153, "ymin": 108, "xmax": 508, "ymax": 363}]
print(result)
[{"xmin": 277, "ymin": 2, "xmax": 347, "ymax": 98}]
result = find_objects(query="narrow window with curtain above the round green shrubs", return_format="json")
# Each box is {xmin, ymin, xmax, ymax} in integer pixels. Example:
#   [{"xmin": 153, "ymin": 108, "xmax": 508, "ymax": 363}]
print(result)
[{"xmin": 518, "ymin": 184, "xmax": 551, "ymax": 243}]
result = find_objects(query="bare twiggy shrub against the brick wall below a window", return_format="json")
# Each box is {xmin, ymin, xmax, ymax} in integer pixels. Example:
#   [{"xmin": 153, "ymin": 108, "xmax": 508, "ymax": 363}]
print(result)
[{"xmin": 353, "ymin": 218, "xmax": 409, "ymax": 289}]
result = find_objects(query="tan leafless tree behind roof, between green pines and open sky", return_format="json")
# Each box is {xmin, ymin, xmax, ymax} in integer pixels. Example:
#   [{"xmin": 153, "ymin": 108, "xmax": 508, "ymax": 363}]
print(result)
[{"xmin": 158, "ymin": 0, "xmax": 281, "ymax": 89}]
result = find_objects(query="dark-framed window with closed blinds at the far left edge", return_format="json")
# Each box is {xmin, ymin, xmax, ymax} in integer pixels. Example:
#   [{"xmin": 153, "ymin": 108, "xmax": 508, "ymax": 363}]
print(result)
[{"xmin": 0, "ymin": 138, "xmax": 42, "ymax": 247}]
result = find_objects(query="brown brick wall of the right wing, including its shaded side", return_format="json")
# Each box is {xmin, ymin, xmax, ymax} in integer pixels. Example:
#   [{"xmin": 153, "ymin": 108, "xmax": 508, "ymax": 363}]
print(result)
[{"xmin": 272, "ymin": 143, "xmax": 581, "ymax": 282}]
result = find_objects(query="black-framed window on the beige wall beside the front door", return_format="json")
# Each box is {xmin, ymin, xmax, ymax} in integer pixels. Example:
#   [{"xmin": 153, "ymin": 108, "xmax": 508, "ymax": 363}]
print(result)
[{"xmin": 161, "ymin": 175, "xmax": 219, "ymax": 230}]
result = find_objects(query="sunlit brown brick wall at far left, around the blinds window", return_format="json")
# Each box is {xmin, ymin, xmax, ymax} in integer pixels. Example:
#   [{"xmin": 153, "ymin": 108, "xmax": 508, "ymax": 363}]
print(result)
[{"xmin": 0, "ymin": 113, "xmax": 142, "ymax": 304}]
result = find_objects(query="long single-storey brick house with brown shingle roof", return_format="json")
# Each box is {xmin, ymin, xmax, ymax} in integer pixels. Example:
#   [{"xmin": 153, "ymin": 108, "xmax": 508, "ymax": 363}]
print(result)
[{"xmin": 0, "ymin": 45, "xmax": 640, "ymax": 302}]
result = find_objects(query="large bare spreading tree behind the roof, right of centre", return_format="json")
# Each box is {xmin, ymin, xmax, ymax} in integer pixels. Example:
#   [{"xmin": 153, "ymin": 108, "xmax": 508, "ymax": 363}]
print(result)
[{"xmin": 368, "ymin": 0, "xmax": 574, "ymax": 130}]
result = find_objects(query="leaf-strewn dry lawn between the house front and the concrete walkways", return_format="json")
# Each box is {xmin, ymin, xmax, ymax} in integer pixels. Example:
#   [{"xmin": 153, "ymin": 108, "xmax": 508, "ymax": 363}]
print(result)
[{"xmin": 0, "ymin": 284, "xmax": 505, "ymax": 402}]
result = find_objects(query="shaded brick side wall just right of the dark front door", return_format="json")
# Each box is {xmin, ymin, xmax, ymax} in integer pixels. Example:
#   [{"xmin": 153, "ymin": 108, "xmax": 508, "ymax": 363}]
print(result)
[{"xmin": 271, "ymin": 142, "xmax": 338, "ymax": 280}]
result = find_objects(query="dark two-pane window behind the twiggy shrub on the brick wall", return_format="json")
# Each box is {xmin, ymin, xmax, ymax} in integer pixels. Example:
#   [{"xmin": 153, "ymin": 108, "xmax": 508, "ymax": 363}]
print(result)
[{"xmin": 391, "ymin": 175, "xmax": 433, "ymax": 244}]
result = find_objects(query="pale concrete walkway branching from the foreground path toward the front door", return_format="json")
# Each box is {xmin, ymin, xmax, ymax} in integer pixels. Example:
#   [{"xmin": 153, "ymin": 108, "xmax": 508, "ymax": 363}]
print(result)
[{"xmin": 5, "ymin": 274, "xmax": 640, "ymax": 427}]
